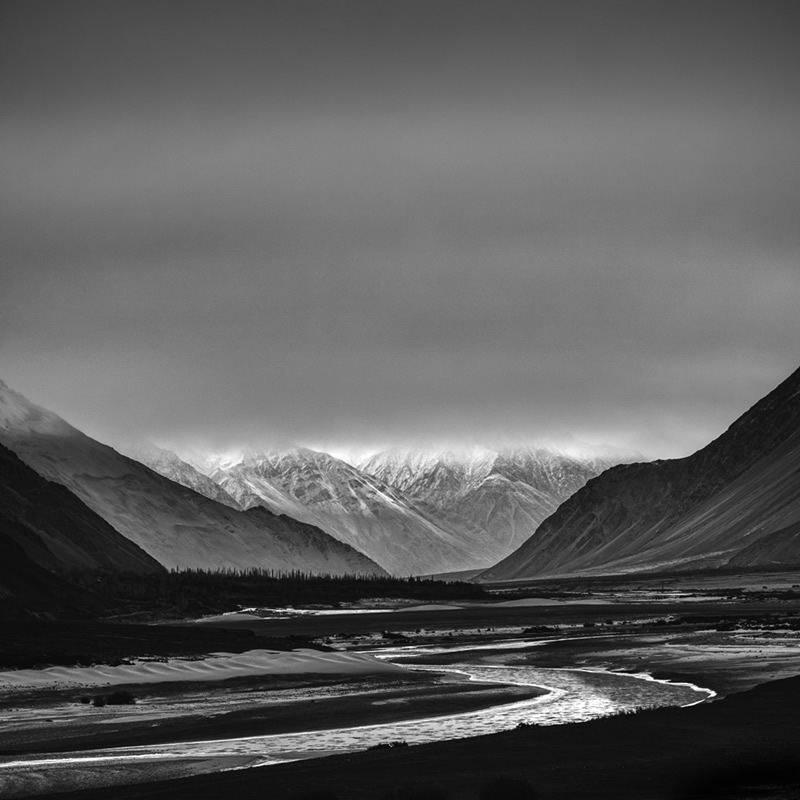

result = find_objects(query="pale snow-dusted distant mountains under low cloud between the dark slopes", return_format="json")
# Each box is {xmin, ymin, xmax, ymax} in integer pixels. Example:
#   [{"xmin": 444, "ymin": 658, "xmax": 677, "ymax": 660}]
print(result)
[{"xmin": 140, "ymin": 447, "xmax": 617, "ymax": 575}]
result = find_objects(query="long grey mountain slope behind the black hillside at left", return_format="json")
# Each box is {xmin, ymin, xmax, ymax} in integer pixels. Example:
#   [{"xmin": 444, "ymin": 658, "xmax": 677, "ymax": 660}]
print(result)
[{"xmin": 0, "ymin": 383, "xmax": 383, "ymax": 574}]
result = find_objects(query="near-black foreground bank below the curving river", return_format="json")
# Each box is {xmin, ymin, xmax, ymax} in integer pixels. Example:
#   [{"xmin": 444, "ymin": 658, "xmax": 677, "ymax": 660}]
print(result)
[{"xmin": 54, "ymin": 678, "xmax": 800, "ymax": 800}]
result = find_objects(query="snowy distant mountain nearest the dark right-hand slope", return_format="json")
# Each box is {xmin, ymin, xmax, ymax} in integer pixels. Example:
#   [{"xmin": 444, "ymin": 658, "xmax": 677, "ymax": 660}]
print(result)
[{"xmin": 362, "ymin": 447, "xmax": 616, "ymax": 559}]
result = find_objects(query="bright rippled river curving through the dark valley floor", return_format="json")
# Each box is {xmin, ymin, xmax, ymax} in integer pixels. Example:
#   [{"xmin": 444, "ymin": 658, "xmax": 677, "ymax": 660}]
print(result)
[{"xmin": 0, "ymin": 641, "xmax": 713, "ymax": 768}]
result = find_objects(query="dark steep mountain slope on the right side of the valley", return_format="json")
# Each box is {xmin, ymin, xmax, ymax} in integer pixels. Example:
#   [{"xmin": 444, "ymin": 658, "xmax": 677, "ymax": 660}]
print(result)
[{"xmin": 481, "ymin": 370, "xmax": 800, "ymax": 580}]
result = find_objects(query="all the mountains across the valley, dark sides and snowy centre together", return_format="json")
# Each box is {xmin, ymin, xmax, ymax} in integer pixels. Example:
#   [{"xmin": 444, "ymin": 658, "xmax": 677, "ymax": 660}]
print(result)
[{"xmin": 0, "ymin": 362, "xmax": 800, "ymax": 584}]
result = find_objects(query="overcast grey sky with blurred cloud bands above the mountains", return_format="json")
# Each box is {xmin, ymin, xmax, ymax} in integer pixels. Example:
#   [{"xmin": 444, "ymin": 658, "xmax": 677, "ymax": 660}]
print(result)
[{"xmin": 0, "ymin": 0, "xmax": 800, "ymax": 458}]
